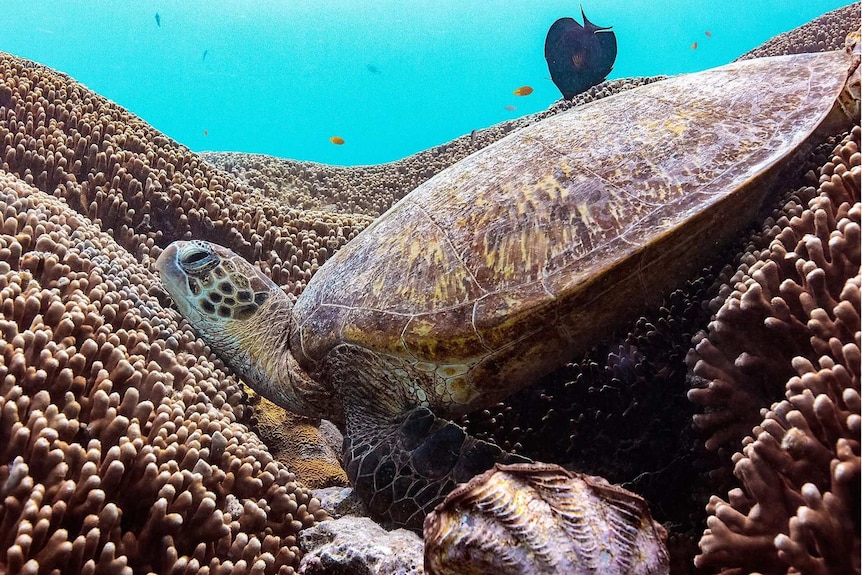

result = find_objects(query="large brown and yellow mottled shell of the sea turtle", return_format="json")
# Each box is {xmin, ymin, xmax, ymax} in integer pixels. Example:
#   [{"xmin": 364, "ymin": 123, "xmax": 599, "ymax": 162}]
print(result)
[{"xmin": 291, "ymin": 52, "xmax": 850, "ymax": 415}]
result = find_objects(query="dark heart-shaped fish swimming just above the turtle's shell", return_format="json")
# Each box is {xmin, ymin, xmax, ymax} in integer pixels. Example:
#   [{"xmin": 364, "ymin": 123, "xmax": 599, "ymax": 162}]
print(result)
[{"xmin": 545, "ymin": 8, "xmax": 617, "ymax": 100}]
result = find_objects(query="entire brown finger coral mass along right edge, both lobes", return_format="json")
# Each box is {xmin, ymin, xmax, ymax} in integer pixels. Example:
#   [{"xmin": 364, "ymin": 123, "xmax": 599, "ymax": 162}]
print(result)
[{"xmin": 689, "ymin": 127, "xmax": 862, "ymax": 573}]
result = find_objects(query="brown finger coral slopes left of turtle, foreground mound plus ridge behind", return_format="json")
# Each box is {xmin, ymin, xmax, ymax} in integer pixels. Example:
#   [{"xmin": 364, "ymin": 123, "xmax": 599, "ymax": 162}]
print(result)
[{"xmin": 0, "ymin": 50, "xmax": 348, "ymax": 573}]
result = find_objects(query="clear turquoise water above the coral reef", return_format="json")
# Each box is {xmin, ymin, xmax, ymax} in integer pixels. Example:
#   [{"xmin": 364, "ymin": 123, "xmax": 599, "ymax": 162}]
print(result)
[{"xmin": 0, "ymin": 0, "xmax": 847, "ymax": 165}]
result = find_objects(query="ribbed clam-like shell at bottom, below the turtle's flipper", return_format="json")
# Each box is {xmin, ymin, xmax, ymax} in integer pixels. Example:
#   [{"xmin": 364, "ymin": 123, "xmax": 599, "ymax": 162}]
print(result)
[{"xmin": 424, "ymin": 463, "xmax": 668, "ymax": 575}]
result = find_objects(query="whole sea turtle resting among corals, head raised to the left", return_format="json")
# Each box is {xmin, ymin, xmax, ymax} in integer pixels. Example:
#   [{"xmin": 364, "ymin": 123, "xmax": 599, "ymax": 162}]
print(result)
[{"xmin": 156, "ymin": 50, "xmax": 858, "ymax": 530}]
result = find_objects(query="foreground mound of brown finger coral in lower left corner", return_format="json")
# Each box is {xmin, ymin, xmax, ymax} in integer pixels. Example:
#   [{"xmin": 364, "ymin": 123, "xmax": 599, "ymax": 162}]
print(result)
[{"xmin": 0, "ymin": 173, "xmax": 325, "ymax": 573}]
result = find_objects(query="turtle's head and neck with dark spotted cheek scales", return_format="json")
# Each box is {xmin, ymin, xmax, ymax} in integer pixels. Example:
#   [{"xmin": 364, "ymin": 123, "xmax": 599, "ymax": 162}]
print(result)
[{"xmin": 155, "ymin": 240, "xmax": 332, "ymax": 417}]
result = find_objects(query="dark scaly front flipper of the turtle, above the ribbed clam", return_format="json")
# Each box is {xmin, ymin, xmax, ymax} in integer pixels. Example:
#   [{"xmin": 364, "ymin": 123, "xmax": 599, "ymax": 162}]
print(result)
[{"xmin": 344, "ymin": 407, "xmax": 530, "ymax": 533}]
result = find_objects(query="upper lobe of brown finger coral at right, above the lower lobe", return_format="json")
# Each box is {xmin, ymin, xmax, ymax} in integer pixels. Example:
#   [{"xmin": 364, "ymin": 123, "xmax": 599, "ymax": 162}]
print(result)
[{"xmin": 687, "ymin": 127, "xmax": 860, "ymax": 456}]
